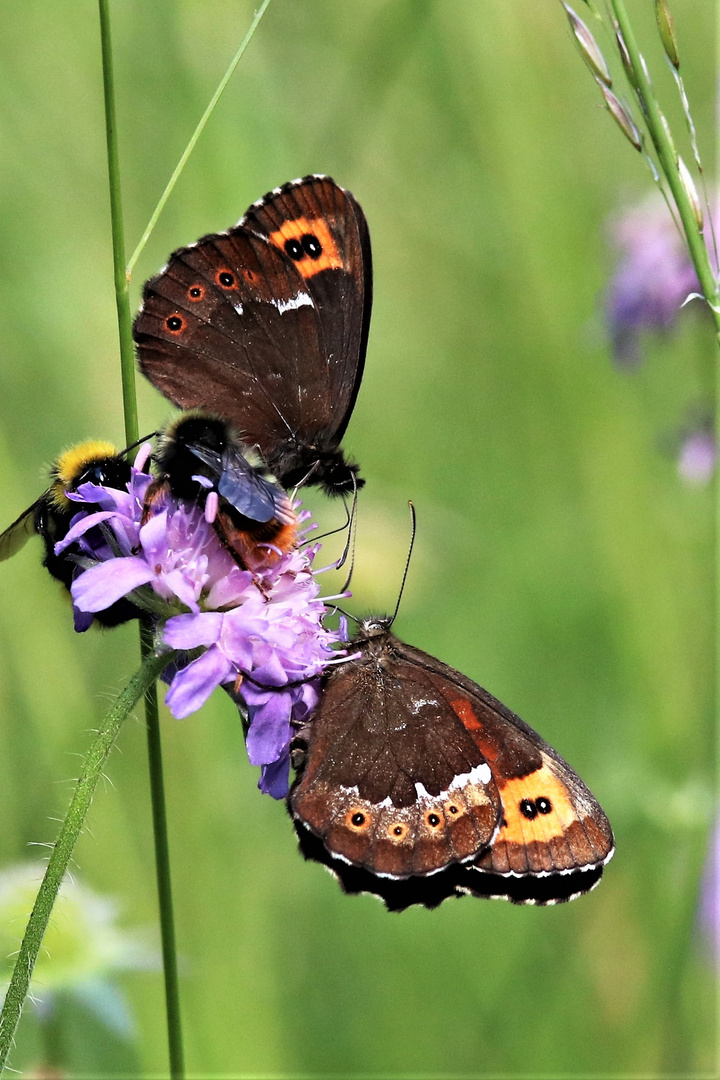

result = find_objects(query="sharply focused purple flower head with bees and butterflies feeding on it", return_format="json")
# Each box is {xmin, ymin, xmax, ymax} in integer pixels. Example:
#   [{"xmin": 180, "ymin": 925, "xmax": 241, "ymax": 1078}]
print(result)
[{"xmin": 55, "ymin": 444, "xmax": 339, "ymax": 798}]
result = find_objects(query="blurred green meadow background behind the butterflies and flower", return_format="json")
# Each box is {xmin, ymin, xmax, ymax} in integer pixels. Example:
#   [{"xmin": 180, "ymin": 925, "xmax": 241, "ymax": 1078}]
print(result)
[{"xmin": 0, "ymin": 0, "xmax": 716, "ymax": 1077}]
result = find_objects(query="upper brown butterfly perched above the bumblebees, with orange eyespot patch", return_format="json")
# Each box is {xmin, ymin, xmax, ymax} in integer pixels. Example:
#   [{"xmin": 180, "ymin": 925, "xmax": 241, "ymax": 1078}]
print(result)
[{"xmin": 133, "ymin": 176, "xmax": 372, "ymax": 495}]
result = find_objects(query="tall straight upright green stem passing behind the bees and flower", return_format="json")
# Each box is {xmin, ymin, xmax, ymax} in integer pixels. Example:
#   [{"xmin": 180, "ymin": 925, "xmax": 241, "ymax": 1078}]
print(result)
[{"xmin": 98, "ymin": 0, "xmax": 185, "ymax": 1080}]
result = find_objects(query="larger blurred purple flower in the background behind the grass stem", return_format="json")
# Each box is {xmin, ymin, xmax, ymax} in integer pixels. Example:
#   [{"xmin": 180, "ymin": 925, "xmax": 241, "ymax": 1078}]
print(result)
[{"xmin": 606, "ymin": 198, "xmax": 709, "ymax": 367}]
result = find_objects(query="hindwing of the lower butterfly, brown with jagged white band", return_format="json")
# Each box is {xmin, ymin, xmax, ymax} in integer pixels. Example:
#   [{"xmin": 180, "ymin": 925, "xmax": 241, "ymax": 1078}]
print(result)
[{"xmin": 289, "ymin": 639, "xmax": 500, "ymax": 878}]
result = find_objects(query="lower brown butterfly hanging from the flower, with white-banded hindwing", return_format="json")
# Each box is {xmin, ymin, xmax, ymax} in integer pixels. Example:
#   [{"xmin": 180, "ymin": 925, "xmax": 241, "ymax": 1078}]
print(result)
[{"xmin": 288, "ymin": 619, "xmax": 614, "ymax": 910}]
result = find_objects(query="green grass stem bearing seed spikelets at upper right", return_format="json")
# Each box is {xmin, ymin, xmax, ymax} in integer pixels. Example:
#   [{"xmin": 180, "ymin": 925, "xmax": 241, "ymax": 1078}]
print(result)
[{"xmin": 610, "ymin": 0, "xmax": 720, "ymax": 345}]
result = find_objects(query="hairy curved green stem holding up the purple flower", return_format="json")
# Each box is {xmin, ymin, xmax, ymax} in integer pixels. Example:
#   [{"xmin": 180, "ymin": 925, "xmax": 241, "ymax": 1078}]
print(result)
[{"xmin": 0, "ymin": 652, "xmax": 175, "ymax": 1070}]
